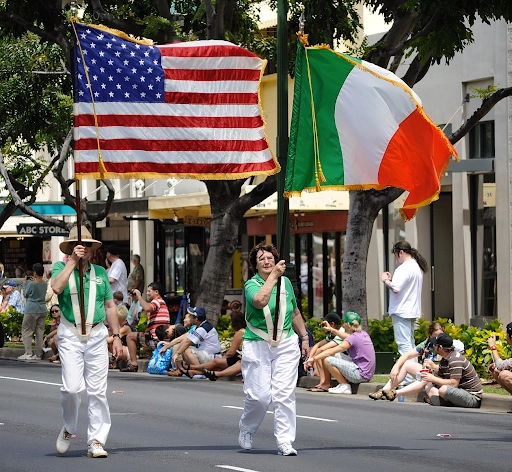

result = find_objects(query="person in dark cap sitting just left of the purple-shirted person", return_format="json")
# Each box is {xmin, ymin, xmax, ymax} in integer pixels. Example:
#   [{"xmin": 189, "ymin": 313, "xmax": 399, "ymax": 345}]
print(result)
[{"xmin": 308, "ymin": 313, "xmax": 349, "ymax": 392}]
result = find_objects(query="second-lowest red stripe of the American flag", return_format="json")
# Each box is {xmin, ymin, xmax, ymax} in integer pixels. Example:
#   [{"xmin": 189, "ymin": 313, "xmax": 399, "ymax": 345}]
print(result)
[{"xmin": 75, "ymin": 138, "xmax": 268, "ymax": 152}]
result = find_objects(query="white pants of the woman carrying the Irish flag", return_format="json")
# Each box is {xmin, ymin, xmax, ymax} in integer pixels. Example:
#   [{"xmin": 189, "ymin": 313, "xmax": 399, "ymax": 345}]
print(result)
[{"xmin": 240, "ymin": 334, "xmax": 300, "ymax": 446}]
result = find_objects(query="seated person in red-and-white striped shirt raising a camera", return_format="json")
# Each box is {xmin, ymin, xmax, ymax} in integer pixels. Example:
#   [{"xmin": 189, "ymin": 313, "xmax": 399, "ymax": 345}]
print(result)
[{"xmin": 121, "ymin": 282, "xmax": 169, "ymax": 372}]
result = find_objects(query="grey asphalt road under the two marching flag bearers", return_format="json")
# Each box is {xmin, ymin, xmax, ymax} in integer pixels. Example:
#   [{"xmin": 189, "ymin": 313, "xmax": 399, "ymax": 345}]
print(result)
[{"xmin": 0, "ymin": 360, "xmax": 512, "ymax": 472}]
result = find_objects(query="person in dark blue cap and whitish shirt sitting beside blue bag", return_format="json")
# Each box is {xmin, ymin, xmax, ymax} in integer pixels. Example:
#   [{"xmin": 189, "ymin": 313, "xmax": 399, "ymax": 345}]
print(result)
[{"xmin": 172, "ymin": 306, "xmax": 222, "ymax": 377}]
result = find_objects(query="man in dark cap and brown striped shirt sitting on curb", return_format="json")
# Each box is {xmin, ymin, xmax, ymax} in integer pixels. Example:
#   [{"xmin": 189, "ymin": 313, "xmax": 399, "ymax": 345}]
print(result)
[{"xmin": 421, "ymin": 333, "xmax": 483, "ymax": 408}]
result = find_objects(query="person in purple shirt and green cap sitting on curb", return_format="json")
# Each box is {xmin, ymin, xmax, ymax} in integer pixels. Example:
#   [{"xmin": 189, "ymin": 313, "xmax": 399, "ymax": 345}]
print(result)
[{"xmin": 305, "ymin": 311, "xmax": 375, "ymax": 395}]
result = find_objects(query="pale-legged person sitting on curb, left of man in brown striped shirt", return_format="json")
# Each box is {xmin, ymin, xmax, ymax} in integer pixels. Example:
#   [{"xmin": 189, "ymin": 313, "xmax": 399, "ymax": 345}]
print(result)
[{"xmin": 368, "ymin": 322, "xmax": 444, "ymax": 401}]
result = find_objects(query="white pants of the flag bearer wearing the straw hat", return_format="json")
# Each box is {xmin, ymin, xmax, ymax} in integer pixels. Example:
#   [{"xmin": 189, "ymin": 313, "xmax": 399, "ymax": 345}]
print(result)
[{"xmin": 57, "ymin": 323, "xmax": 111, "ymax": 445}]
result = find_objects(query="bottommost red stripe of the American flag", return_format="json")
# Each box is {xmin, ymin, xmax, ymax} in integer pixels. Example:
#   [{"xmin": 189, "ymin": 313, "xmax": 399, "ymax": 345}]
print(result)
[{"xmin": 75, "ymin": 159, "xmax": 276, "ymax": 175}]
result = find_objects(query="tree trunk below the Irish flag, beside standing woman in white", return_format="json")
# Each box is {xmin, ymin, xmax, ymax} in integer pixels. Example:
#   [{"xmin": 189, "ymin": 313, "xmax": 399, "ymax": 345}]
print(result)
[{"xmin": 343, "ymin": 187, "xmax": 404, "ymax": 329}]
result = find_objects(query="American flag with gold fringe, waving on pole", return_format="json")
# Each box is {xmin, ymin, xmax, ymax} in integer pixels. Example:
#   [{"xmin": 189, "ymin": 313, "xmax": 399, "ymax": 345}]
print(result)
[{"xmin": 73, "ymin": 23, "xmax": 279, "ymax": 179}]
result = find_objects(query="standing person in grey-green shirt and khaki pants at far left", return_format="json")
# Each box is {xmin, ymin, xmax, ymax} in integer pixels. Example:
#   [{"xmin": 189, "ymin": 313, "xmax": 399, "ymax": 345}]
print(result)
[{"xmin": 18, "ymin": 262, "xmax": 47, "ymax": 361}]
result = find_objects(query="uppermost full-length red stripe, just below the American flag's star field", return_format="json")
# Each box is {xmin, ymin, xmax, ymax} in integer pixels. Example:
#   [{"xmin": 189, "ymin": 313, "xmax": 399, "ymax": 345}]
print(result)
[{"xmin": 73, "ymin": 115, "xmax": 263, "ymax": 129}]
